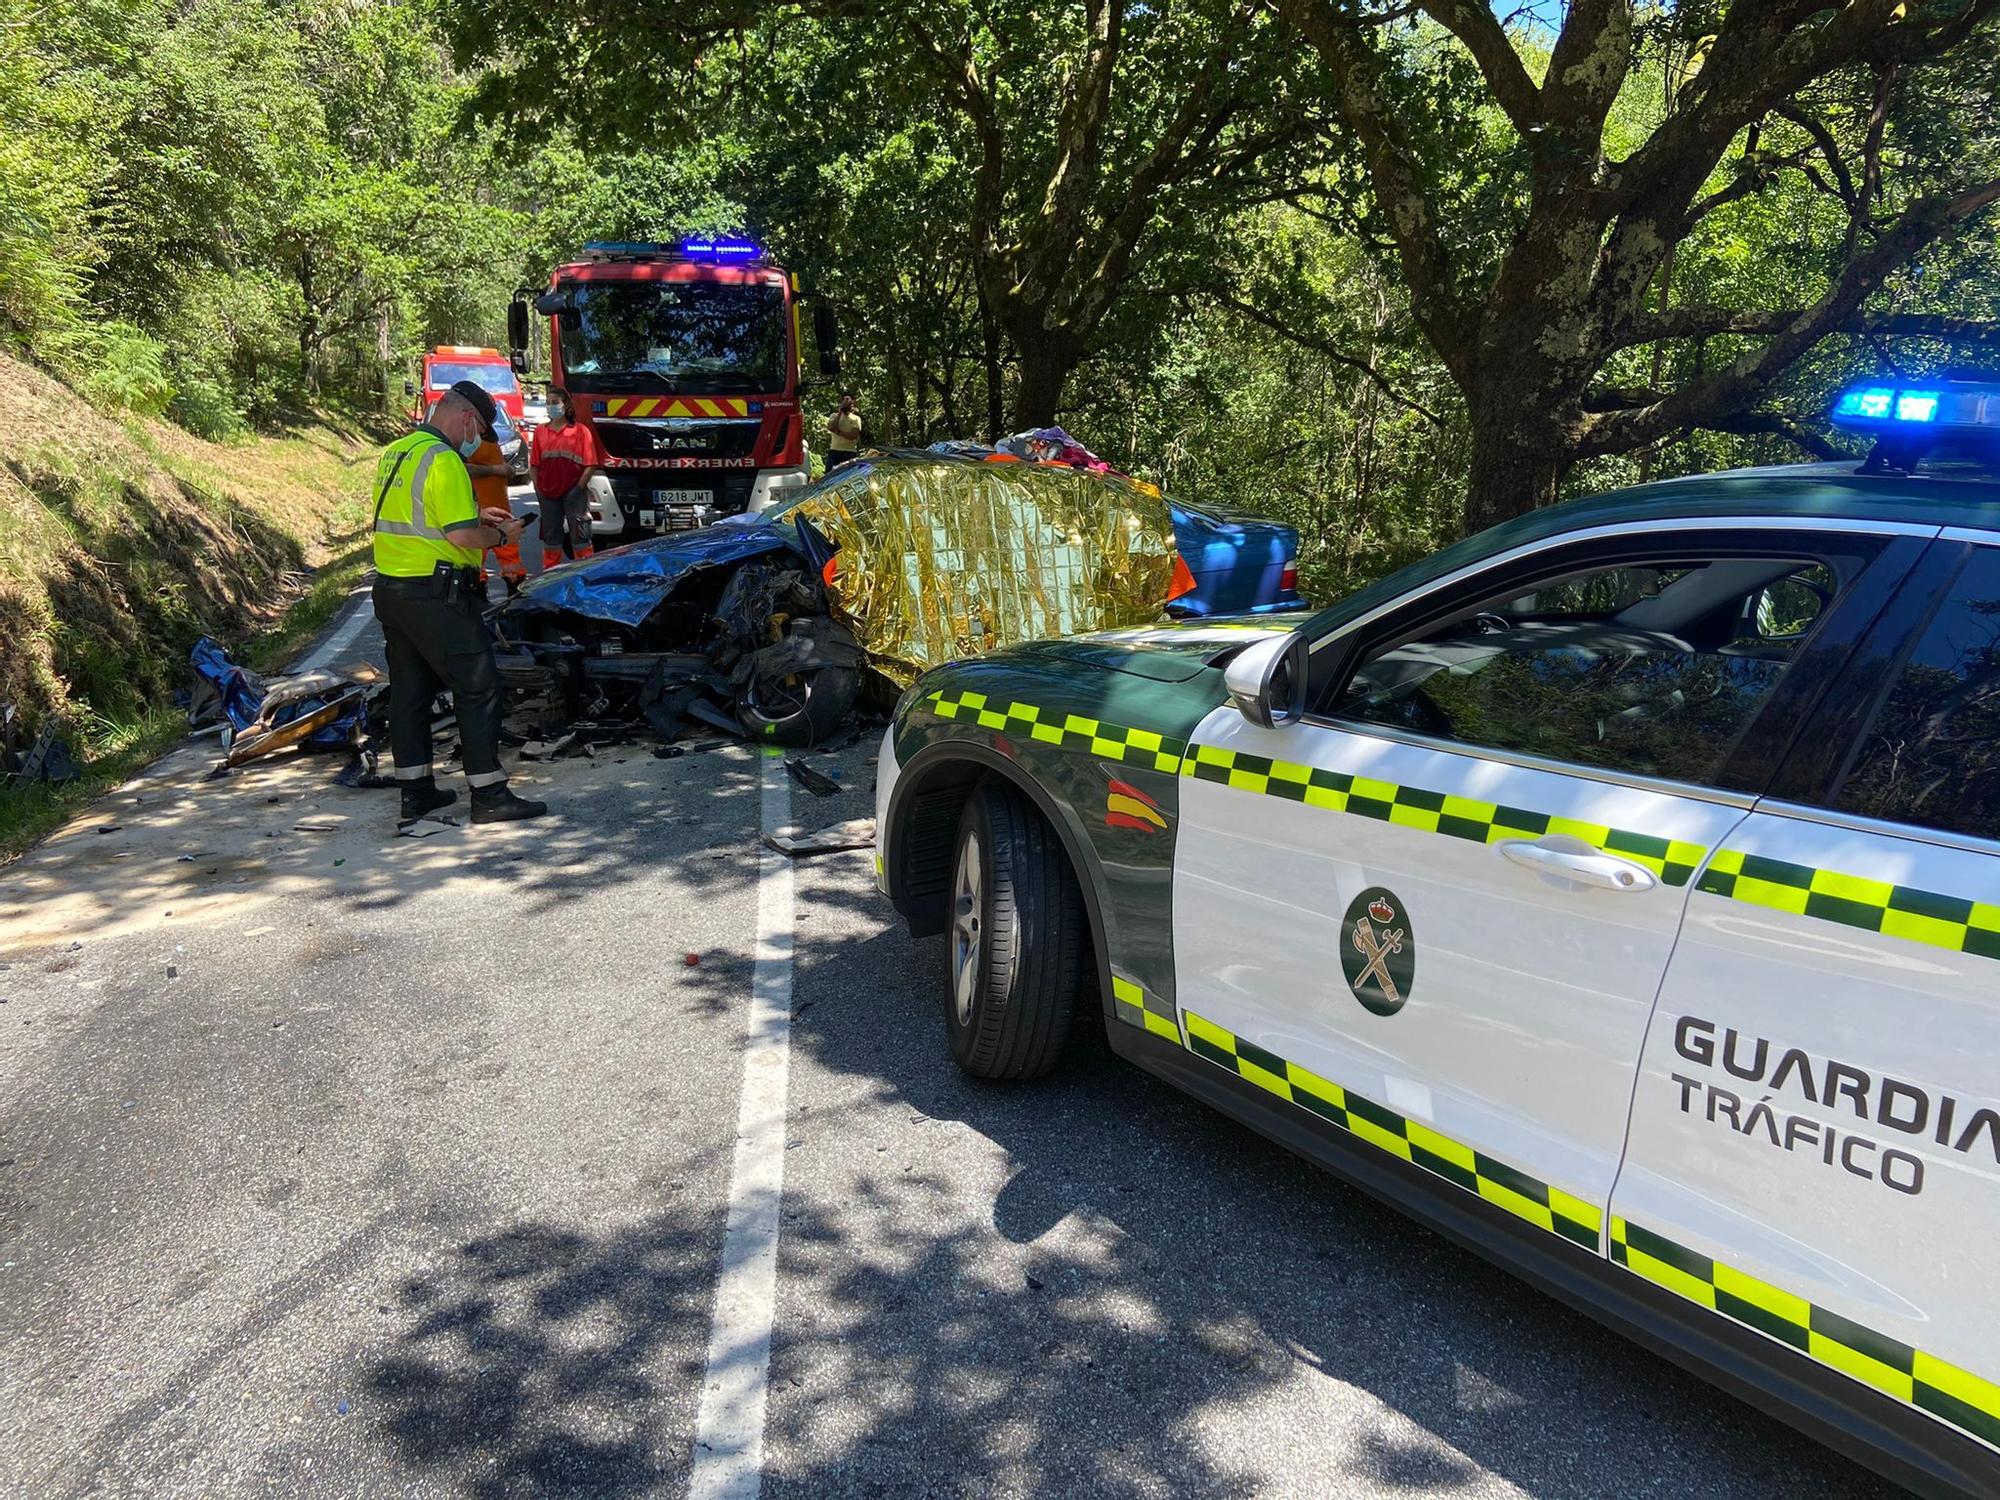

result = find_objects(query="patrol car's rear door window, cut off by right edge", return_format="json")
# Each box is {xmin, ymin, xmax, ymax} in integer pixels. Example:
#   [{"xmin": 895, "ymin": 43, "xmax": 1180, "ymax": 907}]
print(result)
[{"xmin": 1834, "ymin": 546, "xmax": 2000, "ymax": 838}]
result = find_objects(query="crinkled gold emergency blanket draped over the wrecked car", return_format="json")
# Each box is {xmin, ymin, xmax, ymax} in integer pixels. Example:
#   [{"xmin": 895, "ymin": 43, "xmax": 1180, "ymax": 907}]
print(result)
[{"xmin": 792, "ymin": 454, "xmax": 1174, "ymax": 686}]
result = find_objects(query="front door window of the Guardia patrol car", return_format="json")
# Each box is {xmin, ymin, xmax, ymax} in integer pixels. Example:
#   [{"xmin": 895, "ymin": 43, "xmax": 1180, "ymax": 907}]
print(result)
[{"xmin": 1332, "ymin": 558, "xmax": 1836, "ymax": 782}]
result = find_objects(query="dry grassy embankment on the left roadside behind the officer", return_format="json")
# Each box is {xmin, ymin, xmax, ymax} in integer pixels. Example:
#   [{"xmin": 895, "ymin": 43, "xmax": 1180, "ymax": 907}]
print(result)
[{"xmin": 0, "ymin": 356, "xmax": 386, "ymax": 860}]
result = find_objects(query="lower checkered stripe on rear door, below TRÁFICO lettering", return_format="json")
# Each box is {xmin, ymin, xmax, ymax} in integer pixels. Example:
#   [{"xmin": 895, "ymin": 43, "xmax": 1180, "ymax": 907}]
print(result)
[{"xmin": 1612, "ymin": 1218, "xmax": 2000, "ymax": 1446}]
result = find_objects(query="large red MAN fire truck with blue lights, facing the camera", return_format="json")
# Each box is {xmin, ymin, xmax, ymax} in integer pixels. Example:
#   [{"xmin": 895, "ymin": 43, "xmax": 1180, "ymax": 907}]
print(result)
[{"xmin": 508, "ymin": 238, "xmax": 840, "ymax": 544}]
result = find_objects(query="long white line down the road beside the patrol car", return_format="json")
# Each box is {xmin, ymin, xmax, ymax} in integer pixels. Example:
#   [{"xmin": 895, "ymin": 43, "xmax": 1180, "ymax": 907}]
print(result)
[{"xmin": 688, "ymin": 756, "xmax": 792, "ymax": 1500}]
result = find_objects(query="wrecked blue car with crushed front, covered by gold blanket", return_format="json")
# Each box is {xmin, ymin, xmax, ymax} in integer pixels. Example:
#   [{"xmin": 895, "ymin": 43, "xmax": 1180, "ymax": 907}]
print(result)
[{"xmin": 498, "ymin": 444, "xmax": 1302, "ymax": 746}]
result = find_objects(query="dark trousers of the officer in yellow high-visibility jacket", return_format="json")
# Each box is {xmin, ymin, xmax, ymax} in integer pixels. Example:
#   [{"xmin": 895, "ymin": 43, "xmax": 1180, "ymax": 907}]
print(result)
[{"xmin": 374, "ymin": 578, "xmax": 506, "ymax": 786}]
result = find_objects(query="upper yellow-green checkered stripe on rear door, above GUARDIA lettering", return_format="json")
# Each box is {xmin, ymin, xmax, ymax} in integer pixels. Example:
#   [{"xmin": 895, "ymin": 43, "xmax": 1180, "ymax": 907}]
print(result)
[{"xmin": 1694, "ymin": 848, "xmax": 2000, "ymax": 958}]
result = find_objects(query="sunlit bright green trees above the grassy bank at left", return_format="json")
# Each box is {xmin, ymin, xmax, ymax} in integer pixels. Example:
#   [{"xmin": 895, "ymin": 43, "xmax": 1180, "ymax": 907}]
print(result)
[{"xmin": 0, "ymin": 0, "xmax": 734, "ymax": 436}]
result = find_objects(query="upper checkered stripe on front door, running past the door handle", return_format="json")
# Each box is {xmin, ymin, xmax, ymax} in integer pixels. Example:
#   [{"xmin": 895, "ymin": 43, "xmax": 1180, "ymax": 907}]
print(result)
[{"xmin": 1180, "ymin": 744, "xmax": 1708, "ymax": 886}]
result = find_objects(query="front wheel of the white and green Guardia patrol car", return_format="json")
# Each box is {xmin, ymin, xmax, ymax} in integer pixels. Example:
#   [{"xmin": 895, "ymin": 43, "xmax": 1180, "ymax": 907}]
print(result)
[{"xmin": 944, "ymin": 784, "xmax": 1088, "ymax": 1078}]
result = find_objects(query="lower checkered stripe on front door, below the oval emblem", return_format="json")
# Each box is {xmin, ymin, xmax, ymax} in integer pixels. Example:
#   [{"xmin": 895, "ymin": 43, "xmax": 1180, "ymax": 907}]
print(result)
[{"xmin": 1186, "ymin": 1010, "xmax": 1604, "ymax": 1252}]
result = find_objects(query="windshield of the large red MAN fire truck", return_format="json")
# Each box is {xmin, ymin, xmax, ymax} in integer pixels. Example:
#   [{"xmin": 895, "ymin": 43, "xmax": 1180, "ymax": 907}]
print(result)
[{"xmin": 560, "ymin": 282, "xmax": 784, "ymax": 392}]
